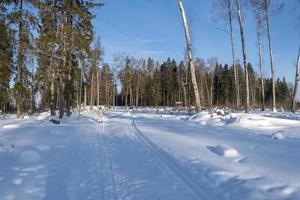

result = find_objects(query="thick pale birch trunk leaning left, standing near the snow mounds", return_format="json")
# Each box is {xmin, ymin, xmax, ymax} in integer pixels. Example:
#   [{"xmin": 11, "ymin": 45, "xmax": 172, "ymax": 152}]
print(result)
[{"xmin": 178, "ymin": 0, "xmax": 201, "ymax": 111}]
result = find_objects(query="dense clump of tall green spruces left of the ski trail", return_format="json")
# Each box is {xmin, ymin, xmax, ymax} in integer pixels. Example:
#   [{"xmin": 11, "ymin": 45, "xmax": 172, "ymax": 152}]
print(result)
[{"xmin": 38, "ymin": 0, "xmax": 103, "ymax": 118}]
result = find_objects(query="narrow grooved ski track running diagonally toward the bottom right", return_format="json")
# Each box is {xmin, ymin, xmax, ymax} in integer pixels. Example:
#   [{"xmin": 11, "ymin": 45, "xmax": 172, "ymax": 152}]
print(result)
[{"xmin": 129, "ymin": 119, "xmax": 214, "ymax": 200}]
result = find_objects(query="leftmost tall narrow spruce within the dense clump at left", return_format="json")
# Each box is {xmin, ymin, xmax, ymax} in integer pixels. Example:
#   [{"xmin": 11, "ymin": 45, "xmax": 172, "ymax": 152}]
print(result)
[{"xmin": 36, "ymin": 1, "xmax": 61, "ymax": 116}]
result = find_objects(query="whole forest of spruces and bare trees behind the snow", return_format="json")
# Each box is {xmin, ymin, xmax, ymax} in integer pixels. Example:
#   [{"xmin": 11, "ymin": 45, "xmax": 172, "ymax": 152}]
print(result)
[{"xmin": 0, "ymin": 0, "xmax": 300, "ymax": 118}]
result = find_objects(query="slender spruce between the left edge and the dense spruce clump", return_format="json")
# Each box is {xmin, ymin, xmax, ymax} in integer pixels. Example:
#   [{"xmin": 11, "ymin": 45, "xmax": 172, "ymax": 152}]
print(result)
[{"xmin": 6, "ymin": 0, "xmax": 38, "ymax": 117}]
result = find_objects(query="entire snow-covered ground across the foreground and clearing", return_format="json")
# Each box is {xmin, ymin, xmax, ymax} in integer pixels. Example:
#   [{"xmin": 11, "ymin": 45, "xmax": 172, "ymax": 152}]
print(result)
[{"xmin": 0, "ymin": 108, "xmax": 300, "ymax": 200}]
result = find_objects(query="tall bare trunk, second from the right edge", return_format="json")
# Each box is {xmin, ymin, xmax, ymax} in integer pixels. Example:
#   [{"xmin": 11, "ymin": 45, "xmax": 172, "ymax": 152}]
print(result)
[{"xmin": 265, "ymin": 0, "xmax": 276, "ymax": 111}]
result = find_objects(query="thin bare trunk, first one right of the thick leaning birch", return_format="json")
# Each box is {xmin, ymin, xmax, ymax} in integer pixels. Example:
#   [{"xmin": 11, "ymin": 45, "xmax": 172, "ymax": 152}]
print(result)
[{"xmin": 227, "ymin": 1, "xmax": 240, "ymax": 110}]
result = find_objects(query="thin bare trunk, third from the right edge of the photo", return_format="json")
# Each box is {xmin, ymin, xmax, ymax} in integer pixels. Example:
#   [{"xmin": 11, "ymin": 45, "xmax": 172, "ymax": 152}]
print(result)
[{"xmin": 257, "ymin": 16, "xmax": 265, "ymax": 111}]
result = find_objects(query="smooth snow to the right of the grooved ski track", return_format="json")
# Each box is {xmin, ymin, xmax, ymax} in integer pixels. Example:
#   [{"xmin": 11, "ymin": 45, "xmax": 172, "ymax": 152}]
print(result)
[{"xmin": 135, "ymin": 111, "xmax": 300, "ymax": 200}]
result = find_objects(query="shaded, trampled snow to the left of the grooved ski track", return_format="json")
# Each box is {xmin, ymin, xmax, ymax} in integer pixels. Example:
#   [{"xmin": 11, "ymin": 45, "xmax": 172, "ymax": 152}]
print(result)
[{"xmin": 0, "ymin": 112, "xmax": 202, "ymax": 200}]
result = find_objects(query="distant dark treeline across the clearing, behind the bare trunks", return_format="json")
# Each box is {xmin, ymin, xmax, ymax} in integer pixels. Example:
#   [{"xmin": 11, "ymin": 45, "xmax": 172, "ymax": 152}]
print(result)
[{"xmin": 118, "ymin": 57, "xmax": 292, "ymax": 108}]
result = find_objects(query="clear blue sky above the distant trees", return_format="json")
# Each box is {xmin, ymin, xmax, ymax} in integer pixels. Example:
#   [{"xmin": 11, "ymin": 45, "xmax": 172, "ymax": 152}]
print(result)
[{"xmin": 94, "ymin": 0, "xmax": 300, "ymax": 82}]
